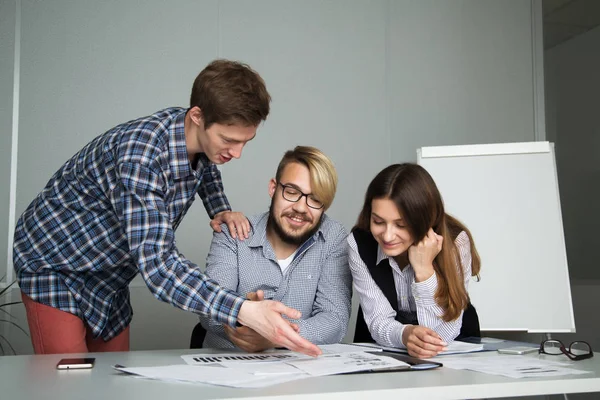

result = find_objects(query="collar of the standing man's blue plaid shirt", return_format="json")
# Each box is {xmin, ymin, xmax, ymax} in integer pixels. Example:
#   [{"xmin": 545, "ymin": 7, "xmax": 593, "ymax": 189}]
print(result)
[{"xmin": 169, "ymin": 109, "xmax": 212, "ymax": 179}]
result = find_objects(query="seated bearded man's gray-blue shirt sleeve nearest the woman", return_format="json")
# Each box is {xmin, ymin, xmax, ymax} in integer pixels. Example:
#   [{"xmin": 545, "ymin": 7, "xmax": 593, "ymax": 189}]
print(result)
[{"xmin": 294, "ymin": 230, "xmax": 352, "ymax": 343}]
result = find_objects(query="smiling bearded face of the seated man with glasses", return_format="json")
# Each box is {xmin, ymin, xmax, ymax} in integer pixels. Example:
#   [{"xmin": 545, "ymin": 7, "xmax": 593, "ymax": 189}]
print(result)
[{"xmin": 268, "ymin": 162, "xmax": 323, "ymax": 245}]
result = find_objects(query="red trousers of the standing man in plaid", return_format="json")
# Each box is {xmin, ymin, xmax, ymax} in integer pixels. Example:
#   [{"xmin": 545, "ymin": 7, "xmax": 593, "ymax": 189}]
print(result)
[{"xmin": 21, "ymin": 293, "xmax": 129, "ymax": 354}]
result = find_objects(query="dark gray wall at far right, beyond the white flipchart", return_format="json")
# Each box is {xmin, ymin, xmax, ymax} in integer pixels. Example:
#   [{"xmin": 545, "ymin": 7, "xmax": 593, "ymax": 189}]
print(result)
[{"xmin": 544, "ymin": 21, "xmax": 600, "ymax": 362}]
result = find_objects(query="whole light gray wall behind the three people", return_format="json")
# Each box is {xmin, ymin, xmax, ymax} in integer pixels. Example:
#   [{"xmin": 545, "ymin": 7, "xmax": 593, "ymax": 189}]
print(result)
[{"xmin": 0, "ymin": 0, "xmax": 535, "ymax": 353}]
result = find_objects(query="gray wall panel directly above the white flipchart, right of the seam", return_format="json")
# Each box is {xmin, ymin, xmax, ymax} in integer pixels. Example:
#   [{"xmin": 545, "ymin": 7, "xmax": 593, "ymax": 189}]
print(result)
[{"xmin": 387, "ymin": 0, "xmax": 534, "ymax": 162}]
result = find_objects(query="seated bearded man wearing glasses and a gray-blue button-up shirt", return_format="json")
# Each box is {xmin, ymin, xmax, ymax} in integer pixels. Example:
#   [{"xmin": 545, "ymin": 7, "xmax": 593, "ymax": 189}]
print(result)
[{"xmin": 197, "ymin": 146, "xmax": 352, "ymax": 352}]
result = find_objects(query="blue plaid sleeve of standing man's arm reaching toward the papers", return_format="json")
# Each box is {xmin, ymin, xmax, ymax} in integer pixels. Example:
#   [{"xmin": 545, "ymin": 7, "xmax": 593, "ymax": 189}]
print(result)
[{"xmin": 117, "ymin": 162, "xmax": 244, "ymax": 326}]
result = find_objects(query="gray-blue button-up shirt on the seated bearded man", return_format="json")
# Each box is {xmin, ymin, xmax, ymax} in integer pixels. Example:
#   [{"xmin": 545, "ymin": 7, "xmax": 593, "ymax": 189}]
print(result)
[{"xmin": 200, "ymin": 213, "xmax": 352, "ymax": 348}]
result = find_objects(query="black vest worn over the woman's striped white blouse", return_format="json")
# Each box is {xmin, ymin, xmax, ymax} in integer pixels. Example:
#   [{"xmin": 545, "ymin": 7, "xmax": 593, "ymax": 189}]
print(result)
[{"xmin": 352, "ymin": 229, "xmax": 481, "ymax": 342}]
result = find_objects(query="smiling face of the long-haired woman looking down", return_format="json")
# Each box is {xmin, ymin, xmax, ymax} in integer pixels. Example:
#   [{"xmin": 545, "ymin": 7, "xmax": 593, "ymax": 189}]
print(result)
[{"xmin": 370, "ymin": 199, "xmax": 413, "ymax": 257}]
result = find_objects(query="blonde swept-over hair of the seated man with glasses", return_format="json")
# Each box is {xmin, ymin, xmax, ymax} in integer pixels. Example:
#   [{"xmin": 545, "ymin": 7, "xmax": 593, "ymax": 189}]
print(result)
[{"xmin": 275, "ymin": 146, "xmax": 337, "ymax": 211}]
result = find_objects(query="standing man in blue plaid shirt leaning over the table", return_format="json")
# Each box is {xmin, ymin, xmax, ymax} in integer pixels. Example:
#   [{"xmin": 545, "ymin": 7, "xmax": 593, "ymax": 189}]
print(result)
[{"xmin": 13, "ymin": 60, "xmax": 320, "ymax": 355}]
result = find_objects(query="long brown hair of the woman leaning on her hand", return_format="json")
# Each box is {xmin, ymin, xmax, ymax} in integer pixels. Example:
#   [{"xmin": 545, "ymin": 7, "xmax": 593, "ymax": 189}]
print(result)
[{"xmin": 354, "ymin": 163, "xmax": 481, "ymax": 321}]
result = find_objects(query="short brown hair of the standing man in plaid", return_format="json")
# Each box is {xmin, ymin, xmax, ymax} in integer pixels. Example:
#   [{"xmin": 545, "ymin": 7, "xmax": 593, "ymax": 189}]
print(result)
[{"xmin": 190, "ymin": 60, "xmax": 271, "ymax": 129}]
